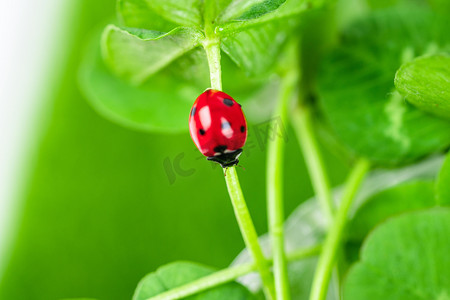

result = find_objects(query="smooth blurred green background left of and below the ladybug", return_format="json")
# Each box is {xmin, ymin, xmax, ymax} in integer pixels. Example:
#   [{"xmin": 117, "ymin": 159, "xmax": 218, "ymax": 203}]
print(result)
[{"xmin": 0, "ymin": 0, "xmax": 345, "ymax": 300}]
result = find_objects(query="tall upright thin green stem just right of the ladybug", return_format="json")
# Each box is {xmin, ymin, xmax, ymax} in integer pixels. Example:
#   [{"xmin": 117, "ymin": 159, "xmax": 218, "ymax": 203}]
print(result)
[{"xmin": 266, "ymin": 76, "xmax": 295, "ymax": 300}]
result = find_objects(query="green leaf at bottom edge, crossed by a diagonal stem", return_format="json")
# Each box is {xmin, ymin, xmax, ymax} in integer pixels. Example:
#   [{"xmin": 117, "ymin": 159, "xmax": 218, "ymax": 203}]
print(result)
[{"xmin": 133, "ymin": 261, "xmax": 253, "ymax": 300}]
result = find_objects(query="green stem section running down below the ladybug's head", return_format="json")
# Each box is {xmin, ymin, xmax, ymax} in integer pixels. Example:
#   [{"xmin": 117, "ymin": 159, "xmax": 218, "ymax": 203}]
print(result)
[{"xmin": 224, "ymin": 166, "xmax": 276, "ymax": 299}]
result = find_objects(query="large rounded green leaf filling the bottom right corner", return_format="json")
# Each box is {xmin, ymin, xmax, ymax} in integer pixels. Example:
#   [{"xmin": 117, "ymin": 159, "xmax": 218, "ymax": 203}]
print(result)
[{"xmin": 343, "ymin": 208, "xmax": 450, "ymax": 300}]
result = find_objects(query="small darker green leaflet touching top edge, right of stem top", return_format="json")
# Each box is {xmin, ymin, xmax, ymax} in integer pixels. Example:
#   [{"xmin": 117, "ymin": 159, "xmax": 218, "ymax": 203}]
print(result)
[{"xmin": 219, "ymin": 0, "xmax": 286, "ymax": 23}]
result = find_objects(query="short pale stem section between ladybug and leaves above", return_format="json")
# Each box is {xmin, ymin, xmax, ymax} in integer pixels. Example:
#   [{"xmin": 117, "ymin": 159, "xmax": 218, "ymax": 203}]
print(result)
[{"xmin": 203, "ymin": 36, "xmax": 222, "ymax": 91}]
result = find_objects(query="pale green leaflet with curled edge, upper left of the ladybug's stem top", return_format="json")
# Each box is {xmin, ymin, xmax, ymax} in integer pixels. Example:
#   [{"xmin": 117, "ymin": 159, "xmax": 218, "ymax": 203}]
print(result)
[{"xmin": 102, "ymin": 25, "xmax": 203, "ymax": 85}]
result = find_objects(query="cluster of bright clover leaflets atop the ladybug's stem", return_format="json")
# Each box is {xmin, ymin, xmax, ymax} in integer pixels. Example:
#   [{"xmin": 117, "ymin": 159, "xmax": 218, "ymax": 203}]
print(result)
[{"xmin": 112, "ymin": 0, "xmax": 314, "ymax": 88}]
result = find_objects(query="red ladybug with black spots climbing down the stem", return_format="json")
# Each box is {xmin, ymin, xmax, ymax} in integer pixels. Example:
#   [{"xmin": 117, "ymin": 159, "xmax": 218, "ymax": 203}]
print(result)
[{"xmin": 189, "ymin": 89, "xmax": 247, "ymax": 168}]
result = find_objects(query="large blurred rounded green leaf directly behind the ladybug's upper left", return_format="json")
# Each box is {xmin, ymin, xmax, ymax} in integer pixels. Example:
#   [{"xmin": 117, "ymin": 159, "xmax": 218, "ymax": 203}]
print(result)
[{"xmin": 83, "ymin": 29, "xmax": 274, "ymax": 133}]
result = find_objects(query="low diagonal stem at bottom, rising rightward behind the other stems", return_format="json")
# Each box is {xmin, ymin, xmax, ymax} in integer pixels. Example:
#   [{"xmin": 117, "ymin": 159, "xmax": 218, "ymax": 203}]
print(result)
[{"xmin": 148, "ymin": 245, "xmax": 321, "ymax": 300}]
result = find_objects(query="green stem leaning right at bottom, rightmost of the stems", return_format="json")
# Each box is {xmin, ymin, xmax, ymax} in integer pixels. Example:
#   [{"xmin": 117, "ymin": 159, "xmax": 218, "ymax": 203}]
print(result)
[{"xmin": 309, "ymin": 159, "xmax": 370, "ymax": 300}]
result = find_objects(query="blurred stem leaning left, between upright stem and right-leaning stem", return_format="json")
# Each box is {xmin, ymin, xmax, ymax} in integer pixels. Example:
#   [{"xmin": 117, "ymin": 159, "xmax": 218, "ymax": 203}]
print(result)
[{"xmin": 291, "ymin": 103, "xmax": 334, "ymax": 222}]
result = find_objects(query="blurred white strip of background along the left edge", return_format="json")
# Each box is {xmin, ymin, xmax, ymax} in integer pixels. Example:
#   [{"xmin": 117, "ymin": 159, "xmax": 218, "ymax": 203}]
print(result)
[{"xmin": 0, "ymin": 0, "xmax": 67, "ymax": 276}]
